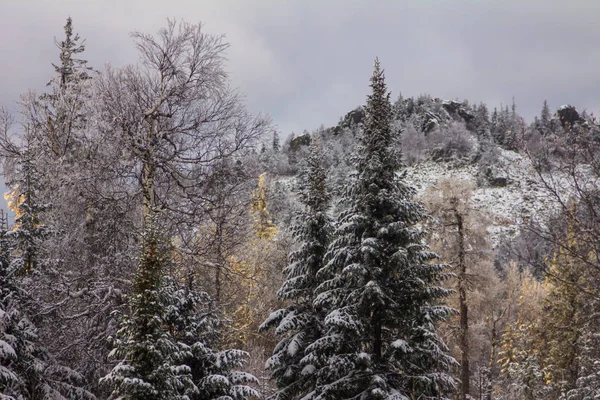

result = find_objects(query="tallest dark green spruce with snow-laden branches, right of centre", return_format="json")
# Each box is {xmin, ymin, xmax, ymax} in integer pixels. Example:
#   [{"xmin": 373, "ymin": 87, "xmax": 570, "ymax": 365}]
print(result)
[{"xmin": 306, "ymin": 60, "xmax": 456, "ymax": 399}]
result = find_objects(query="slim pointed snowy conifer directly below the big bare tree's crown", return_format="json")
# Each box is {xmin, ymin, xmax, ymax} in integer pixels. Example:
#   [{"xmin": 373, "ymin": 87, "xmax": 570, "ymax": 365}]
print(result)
[{"xmin": 101, "ymin": 216, "xmax": 190, "ymax": 400}]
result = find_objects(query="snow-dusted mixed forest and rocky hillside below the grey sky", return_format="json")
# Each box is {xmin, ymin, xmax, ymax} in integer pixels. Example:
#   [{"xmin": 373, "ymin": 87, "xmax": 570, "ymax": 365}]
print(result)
[{"xmin": 0, "ymin": 18, "xmax": 600, "ymax": 400}]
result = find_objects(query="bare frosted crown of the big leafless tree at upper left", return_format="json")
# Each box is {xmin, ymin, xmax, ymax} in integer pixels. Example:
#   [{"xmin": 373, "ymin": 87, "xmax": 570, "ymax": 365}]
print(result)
[{"xmin": 96, "ymin": 21, "xmax": 269, "ymax": 228}]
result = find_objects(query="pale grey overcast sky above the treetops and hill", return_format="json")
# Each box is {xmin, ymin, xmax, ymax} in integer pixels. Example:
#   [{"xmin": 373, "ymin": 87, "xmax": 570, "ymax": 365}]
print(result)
[{"xmin": 0, "ymin": 0, "xmax": 600, "ymax": 135}]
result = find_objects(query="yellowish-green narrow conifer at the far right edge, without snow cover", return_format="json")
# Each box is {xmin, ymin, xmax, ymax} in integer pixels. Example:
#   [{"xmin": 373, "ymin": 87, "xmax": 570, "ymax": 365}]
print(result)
[{"xmin": 541, "ymin": 208, "xmax": 600, "ymax": 398}]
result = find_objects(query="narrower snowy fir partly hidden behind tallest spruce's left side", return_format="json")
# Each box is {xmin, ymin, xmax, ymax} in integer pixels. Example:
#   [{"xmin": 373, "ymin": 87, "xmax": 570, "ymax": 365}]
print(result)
[{"xmin": 260, "ymin": 139, "xmax": 331, "ymax": 400}]
